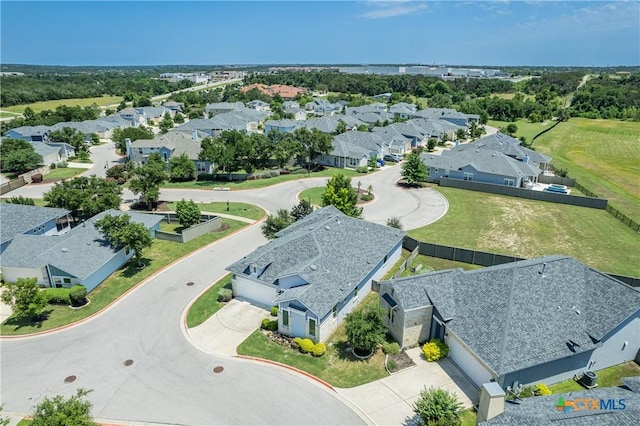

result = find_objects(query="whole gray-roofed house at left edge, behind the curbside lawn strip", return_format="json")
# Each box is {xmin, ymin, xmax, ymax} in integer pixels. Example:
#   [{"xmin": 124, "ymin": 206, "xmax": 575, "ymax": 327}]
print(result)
[{"xmin": 2, "ymin": 210, "xmax": 163, "ymax": 291}]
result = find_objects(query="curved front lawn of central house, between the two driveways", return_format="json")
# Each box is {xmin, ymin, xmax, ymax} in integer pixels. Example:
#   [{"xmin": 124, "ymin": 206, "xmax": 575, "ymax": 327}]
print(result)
[{"xmin": 237, "ymin": 293, "xmax": 388, "ymax": 388}]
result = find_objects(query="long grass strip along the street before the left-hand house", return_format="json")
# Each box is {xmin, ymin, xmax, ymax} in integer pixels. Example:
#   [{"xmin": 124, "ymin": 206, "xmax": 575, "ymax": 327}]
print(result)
[{"xmin": 0, "ymin": 219, "xmax": 247, "ymax": 336}]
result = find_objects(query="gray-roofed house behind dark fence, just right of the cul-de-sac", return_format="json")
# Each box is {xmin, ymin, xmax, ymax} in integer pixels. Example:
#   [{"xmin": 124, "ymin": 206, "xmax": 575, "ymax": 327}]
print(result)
[{"xmin": 420, "ymin": 133, "xmax": 551, "ymax": 187}]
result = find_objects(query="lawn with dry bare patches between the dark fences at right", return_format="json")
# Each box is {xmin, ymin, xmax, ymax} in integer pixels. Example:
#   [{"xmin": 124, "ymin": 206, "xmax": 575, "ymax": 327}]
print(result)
[{"xmin": 408, "ymin": 187, "xmax": 640, "ymax": 276}]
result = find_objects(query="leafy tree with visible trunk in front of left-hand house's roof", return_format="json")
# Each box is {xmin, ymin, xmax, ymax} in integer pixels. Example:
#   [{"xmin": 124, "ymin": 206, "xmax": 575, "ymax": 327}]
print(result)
[{"xmin": 94, "ymin": 214, "xmax": 153, "ymax": 266}]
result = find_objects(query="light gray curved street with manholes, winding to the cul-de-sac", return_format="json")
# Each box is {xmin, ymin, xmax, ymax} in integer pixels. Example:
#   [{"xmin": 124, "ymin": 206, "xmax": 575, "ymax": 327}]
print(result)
[{"xmin": 0, "ymin": 147, "xmax": 447, "ymax": 425}]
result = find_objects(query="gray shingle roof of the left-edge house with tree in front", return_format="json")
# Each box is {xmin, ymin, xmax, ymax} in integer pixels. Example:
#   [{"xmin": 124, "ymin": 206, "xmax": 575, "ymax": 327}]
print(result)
[{"xmin": 2, "ymin": 210, "xmax": 163, "ymax": 280}]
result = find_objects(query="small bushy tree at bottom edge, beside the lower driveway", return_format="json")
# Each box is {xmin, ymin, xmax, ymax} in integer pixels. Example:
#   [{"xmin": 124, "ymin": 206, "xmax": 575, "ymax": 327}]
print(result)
[{"xmin": 413, "ymin": 387, "xmax": 462, "ymax": 426}]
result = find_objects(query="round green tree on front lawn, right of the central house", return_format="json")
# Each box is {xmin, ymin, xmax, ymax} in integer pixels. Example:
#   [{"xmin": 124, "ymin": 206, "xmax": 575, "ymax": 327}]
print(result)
[{"xmin": 345, "ymin": 306, "xmax": 387, "ymax": 353}]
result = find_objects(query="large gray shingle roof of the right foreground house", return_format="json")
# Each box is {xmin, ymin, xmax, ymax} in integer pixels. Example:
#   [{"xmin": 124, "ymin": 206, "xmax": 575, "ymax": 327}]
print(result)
[{"xmin": 382, "ymin": 256, "xmax": 640, "ymax": 375}]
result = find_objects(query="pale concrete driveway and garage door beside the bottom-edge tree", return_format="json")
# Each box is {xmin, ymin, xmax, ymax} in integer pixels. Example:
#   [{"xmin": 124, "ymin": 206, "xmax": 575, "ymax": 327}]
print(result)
[{"xmin": 338, "ymin": 348, "xmax": 478, "ymax": 425}]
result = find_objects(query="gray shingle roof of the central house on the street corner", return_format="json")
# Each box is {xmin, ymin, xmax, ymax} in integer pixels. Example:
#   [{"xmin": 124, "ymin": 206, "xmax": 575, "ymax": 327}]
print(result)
[{"xmin": 227, "ymin": 206, "xmax": 405, "ymax": 317}]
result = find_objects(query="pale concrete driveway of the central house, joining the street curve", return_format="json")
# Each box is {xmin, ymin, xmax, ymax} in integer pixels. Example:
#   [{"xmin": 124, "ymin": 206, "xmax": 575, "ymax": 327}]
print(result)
[{"xmin": 188, "ymin": 298, "xmax": 270, "ymax": 356}]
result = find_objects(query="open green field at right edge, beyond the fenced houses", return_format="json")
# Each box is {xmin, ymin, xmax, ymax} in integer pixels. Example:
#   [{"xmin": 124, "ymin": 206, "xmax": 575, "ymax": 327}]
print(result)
[{"xmin": 533, "ymin": 118, "xmax": 640, "ymax": 222}]
